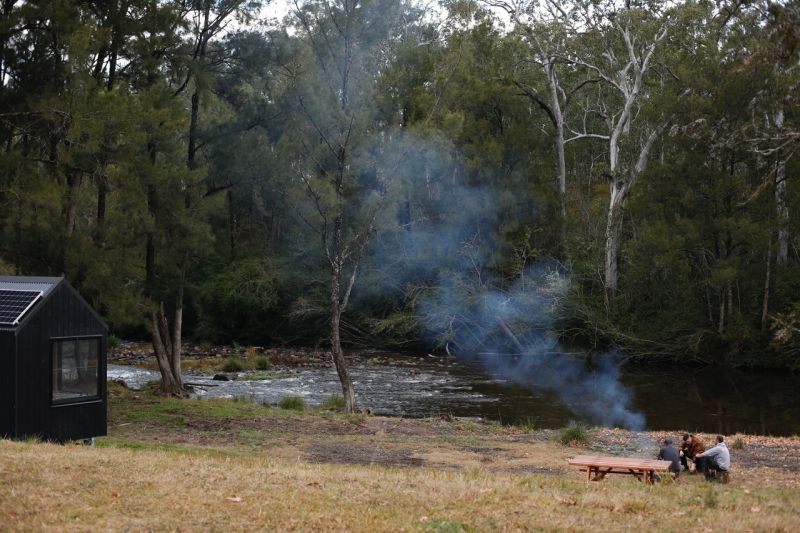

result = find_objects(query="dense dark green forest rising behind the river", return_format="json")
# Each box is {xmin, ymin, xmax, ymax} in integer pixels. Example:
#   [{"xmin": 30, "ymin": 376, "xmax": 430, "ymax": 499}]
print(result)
[{"xmin": 0, "ymin": 0, "xmax": 800, "ymax": 386}]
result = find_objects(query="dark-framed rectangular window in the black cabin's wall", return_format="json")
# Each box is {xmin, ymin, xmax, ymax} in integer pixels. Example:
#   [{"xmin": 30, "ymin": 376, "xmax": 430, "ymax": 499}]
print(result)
[{"xmin": 50, "ymin": 338, "xmax": 100, "ymax": 402}]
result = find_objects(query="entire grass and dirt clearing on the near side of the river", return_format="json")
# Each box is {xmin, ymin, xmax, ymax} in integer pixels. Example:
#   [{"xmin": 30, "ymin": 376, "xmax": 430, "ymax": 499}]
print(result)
[{"xmin": 0, "ymin": 387, "xmax": 800, "ymax": 531}]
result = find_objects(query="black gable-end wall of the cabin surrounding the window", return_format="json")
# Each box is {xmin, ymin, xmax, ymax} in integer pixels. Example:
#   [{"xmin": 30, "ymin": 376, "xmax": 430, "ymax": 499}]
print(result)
[{"xmin": 17, "ymin": 283, "xmax": 106, "ymax": 440}]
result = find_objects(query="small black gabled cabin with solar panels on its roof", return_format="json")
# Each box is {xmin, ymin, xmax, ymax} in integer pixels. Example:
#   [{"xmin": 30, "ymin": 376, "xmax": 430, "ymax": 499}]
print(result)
[{"xmin": 0, "ymin": 276, "xmax": 108, "ymax": 441}]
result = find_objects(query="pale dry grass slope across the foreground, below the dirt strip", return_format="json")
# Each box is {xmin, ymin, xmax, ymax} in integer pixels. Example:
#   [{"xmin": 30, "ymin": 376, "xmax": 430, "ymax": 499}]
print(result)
[{"xmin": 0, "ymin": 441, "xmax": 800, "ymax": 531}]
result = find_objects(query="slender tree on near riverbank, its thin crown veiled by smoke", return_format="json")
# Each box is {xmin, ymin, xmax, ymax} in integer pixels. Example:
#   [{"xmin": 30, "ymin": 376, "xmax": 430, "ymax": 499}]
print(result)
[{"xmin": 291, "ymin": 0, "xmax": 422, "ymax": 412}]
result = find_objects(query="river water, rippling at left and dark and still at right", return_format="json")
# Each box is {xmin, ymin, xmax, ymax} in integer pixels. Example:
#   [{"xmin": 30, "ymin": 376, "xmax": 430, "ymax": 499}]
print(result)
[{"xmin": 108, "ymin": 354, "xmax": 800, "ymax": 435}]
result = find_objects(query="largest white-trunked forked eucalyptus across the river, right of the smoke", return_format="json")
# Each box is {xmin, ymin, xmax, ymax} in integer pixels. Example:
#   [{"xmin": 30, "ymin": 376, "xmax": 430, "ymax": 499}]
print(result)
[{"xmin": 570, "ymin": 0, "xmax": 669, "ymax": 300}]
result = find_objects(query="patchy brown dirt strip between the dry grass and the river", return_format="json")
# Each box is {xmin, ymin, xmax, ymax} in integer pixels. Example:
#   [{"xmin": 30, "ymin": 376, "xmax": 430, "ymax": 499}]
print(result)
[{"xmin": 109, "ymin": 388, "xmax": 800, "ymax": 487}]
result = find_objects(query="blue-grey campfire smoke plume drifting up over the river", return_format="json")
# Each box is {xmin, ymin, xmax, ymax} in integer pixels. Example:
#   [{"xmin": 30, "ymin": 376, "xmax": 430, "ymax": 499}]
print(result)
[{"xmin": 370, "ymin": 134, "xmax": 645, "ymax": 430}]
